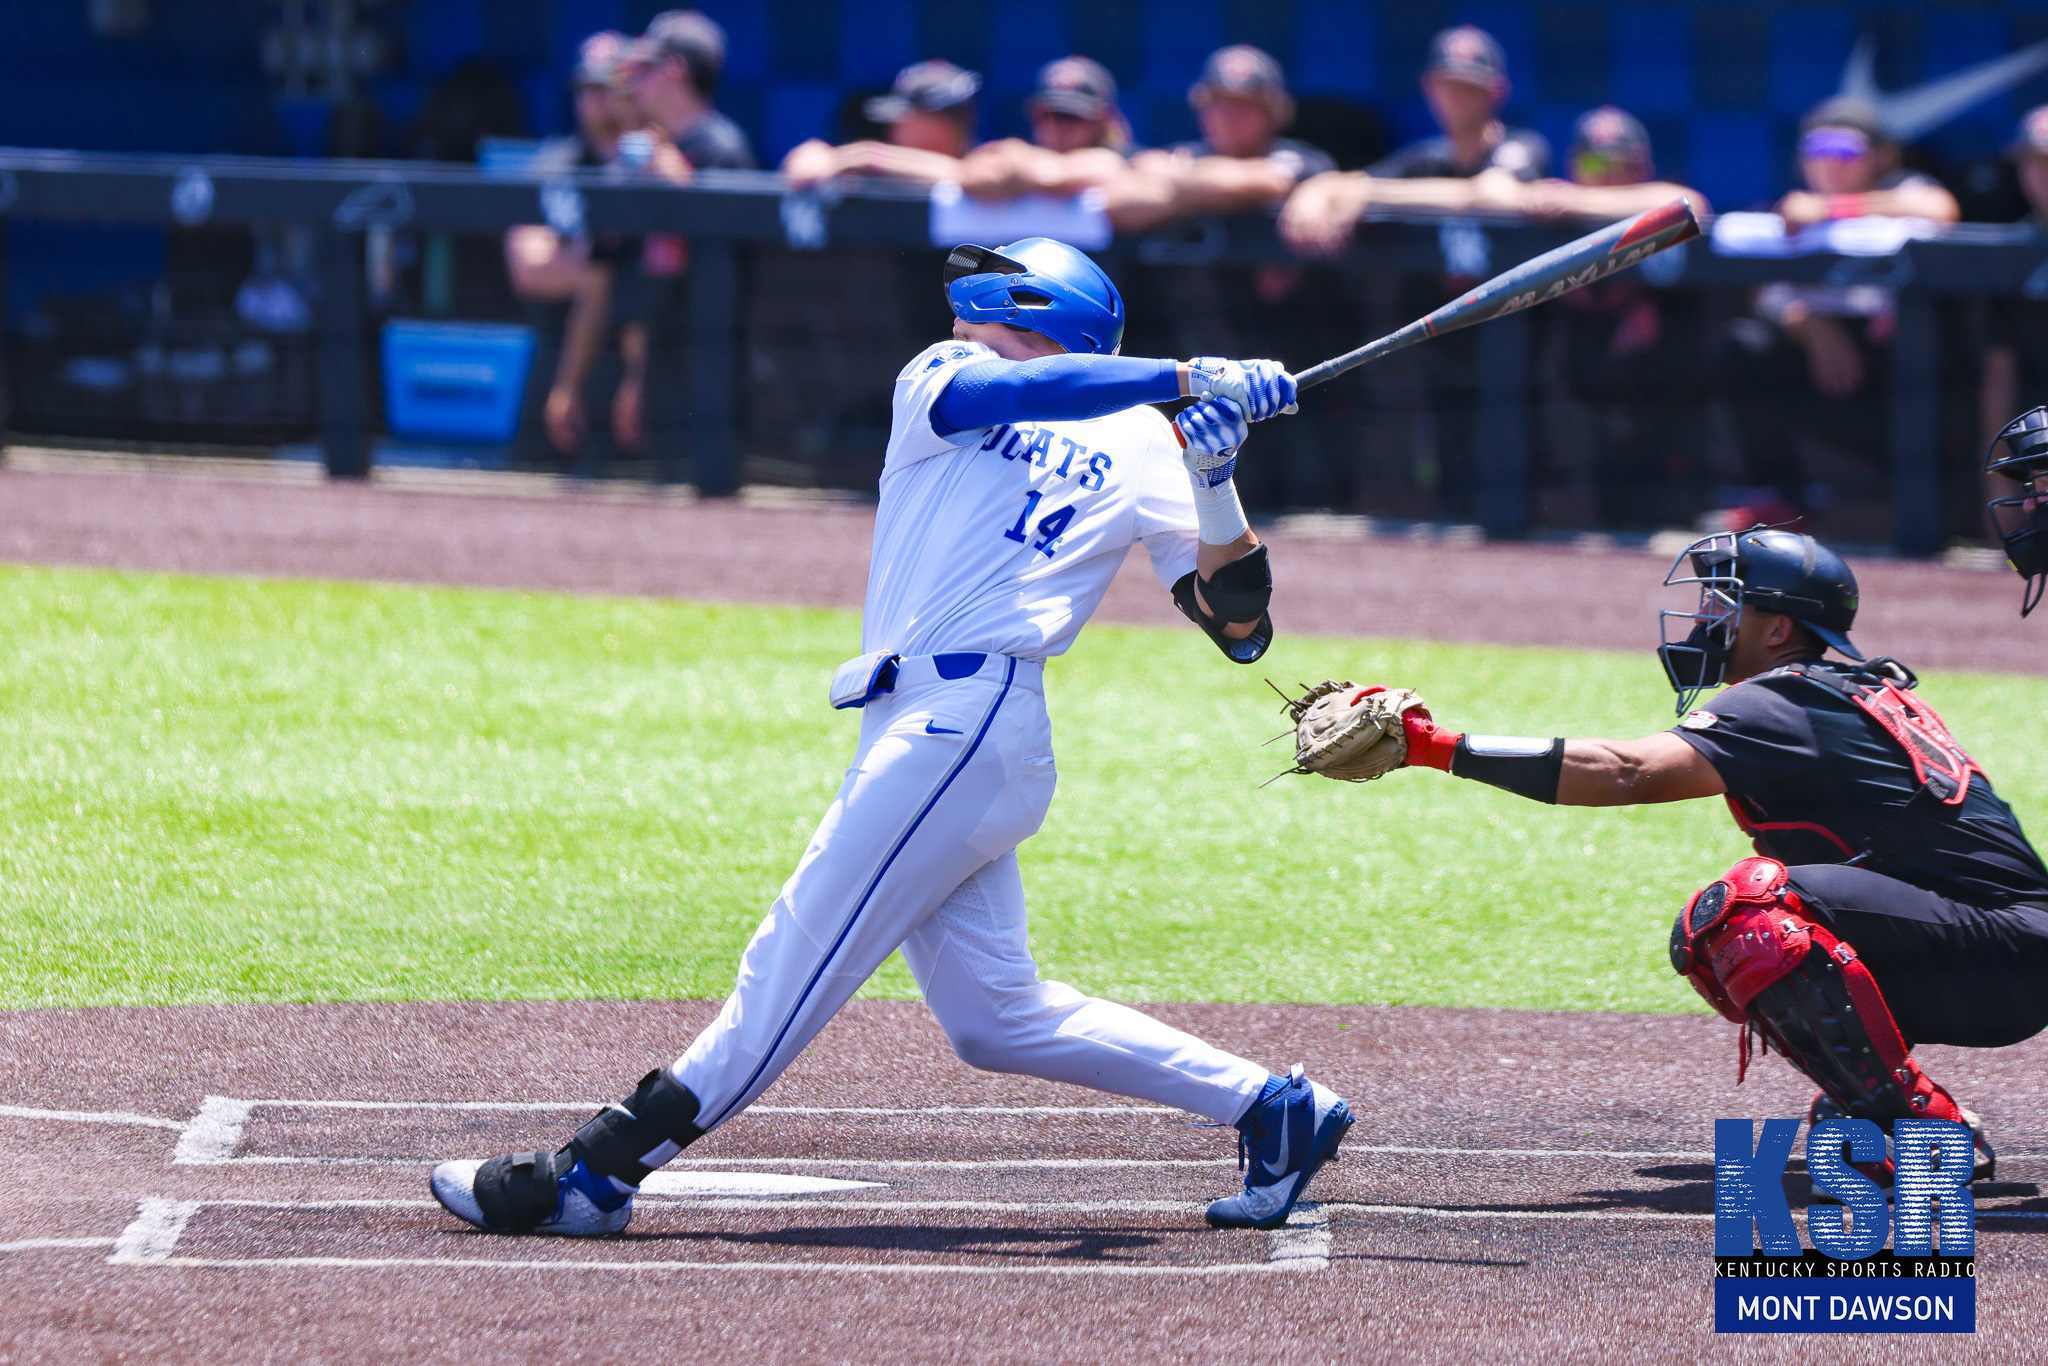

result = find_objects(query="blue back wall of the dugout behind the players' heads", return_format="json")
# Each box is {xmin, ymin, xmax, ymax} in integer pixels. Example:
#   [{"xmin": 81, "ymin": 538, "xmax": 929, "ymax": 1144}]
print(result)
[{"xmin": 0, "ymin": 0, "xmax": 2048, "ymax": 214}]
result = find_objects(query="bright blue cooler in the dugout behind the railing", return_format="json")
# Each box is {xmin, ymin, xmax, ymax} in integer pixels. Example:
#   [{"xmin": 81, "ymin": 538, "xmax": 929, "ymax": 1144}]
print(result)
[{"xmin": 383, "ymin": 322, "xmax": 532, "ymax": 446}]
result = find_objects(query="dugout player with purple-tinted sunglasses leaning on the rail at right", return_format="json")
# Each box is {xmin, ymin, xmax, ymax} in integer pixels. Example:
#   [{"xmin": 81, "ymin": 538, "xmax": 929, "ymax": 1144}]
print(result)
[{"xmin": 1720, "ymin": 96, "xmax": 1957, "ymax": 522}]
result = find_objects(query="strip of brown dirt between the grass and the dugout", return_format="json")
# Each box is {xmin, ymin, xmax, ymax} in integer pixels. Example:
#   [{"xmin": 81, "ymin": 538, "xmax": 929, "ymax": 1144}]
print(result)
[{"xmin": 0, "ymin": 457, "xmax": 2048, "ymax": 674}]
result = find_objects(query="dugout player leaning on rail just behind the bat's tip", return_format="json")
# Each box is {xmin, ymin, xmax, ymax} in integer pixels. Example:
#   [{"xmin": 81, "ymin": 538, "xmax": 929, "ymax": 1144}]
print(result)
[{"xmin": 1540, "ymin": 104, "xmax": 1706, "ymax": 528}]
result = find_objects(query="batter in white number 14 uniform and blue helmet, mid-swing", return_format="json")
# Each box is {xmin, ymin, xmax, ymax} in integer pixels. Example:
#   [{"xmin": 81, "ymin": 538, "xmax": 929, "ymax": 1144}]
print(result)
[{"xmin": 430, "ymin": 238, "xmax": 1352, "ymax": 1235}]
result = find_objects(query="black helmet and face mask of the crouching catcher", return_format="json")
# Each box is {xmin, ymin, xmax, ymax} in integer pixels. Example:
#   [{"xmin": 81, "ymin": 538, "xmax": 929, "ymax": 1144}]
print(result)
[{"xmin": 1657, "ymin": 526, "xmax": 1864, "ymax": 717}]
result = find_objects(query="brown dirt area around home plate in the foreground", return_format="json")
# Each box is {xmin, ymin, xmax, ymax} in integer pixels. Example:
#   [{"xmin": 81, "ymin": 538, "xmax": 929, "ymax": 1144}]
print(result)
[{"xmin": 0, "ymin": 1001, "xmax": 2048, "ymax": 1364}]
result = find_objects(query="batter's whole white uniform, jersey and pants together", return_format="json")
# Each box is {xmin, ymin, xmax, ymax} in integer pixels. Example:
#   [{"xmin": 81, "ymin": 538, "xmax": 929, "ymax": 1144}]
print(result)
[{"xmin": 655, "ymin": 333, "xmax": 1270, "ymax": 1128}]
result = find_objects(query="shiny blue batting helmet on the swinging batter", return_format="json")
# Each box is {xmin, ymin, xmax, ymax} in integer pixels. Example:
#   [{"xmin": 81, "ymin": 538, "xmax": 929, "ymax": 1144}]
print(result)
[{"xmin": 942, "ymin": 238, "xmax": 1124, "ymax": 356}]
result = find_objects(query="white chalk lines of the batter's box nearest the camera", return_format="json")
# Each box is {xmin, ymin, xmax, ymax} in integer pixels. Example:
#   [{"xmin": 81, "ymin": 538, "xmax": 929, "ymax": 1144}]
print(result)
[{"xmin": 103, "ymin": 1196, "xmax": 1329, "ymax": 1276}]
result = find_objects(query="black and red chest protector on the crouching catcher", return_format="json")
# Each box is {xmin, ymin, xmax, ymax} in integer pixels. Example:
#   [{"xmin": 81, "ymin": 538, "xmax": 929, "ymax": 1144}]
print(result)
[{"xmin": 1729, "ymin": 659, "xmax": 1985, "ymax": 862}]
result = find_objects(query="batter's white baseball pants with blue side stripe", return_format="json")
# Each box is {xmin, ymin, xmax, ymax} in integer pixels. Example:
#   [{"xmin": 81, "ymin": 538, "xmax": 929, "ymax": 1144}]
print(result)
[{"xmin": 674, "ymin": 655, "xmax": 1268, "ymax": 1128}]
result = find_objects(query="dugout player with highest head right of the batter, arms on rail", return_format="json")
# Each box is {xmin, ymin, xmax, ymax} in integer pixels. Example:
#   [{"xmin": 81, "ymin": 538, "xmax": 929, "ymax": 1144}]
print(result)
[{"xmin": 1280, "ymin": 25, "xmax": 1550, "ymax": 256}]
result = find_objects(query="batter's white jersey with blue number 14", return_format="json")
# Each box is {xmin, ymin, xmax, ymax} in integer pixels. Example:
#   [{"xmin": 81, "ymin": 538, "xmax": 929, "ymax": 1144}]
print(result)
[{"xmin": 860, "ymin": 342, "xmax": 1198, "ymax": 659}]
